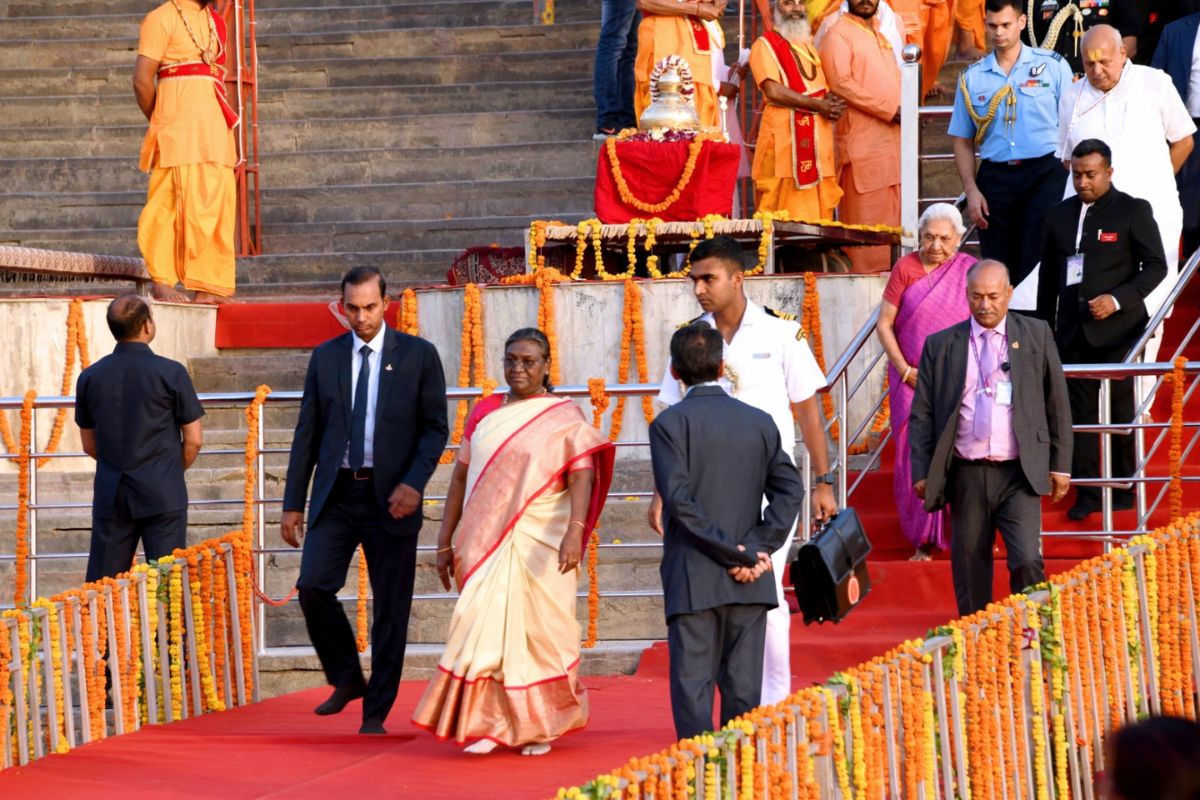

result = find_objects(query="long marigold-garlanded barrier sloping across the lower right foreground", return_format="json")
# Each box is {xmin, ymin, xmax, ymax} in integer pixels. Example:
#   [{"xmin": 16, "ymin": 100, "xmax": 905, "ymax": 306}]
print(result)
[{"xmin": 557, "ymin": 512, "xmax": 1200, "ymax": 800}]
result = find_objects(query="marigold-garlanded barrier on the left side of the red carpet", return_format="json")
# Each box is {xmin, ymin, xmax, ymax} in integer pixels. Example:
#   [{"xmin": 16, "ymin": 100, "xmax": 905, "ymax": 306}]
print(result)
[{"xmin": 0, "ymin": 531, "xmax": 253, "ymax": 769}]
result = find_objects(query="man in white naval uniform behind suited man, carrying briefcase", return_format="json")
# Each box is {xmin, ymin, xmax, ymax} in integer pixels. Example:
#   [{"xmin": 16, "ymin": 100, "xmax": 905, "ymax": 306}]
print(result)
[{"xmin": 649, "ymin": 236, "xmax": 838, "ymax": 704}]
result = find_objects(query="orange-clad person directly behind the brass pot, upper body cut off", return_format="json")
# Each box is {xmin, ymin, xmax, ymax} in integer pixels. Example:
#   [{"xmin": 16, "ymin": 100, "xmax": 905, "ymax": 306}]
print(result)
[{"xmin": 634, "ymin": 0, "xmax": 726, "ymax": 130}]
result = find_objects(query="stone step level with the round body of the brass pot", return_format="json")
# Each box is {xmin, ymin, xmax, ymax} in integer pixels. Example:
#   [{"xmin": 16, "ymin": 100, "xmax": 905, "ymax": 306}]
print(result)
[{"xmin": 0, "ymin": 104, "xmax": 595, "ymax": 161}]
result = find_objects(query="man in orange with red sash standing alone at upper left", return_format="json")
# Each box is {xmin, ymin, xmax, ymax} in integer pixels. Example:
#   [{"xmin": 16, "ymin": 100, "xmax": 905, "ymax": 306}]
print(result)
[{"xmin": 133, "ymin": 0, "xmax": 238, "ymax": 302}]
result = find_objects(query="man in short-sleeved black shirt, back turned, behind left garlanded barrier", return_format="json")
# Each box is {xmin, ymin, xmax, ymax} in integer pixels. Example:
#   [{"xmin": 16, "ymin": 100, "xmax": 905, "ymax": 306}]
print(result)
[{"xmin": 76, "ymin": 295, "xmax": 204, "ymax": 581}]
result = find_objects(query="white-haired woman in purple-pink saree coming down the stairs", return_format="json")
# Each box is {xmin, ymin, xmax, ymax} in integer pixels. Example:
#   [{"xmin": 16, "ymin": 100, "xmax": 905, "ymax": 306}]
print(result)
[{"xmin": 875, "ymin": 203, "xmax": 976, "ymax": 561}]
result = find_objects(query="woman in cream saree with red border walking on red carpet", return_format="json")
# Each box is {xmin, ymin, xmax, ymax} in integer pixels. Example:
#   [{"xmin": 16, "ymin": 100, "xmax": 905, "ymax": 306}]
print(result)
[{"xmin": 413, "ymin": 329, "xmax": 613, "ymax": 756}]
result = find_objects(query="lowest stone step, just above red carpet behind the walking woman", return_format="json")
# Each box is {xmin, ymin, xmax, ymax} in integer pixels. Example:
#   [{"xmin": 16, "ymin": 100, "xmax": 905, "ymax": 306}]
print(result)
[{"xmin": 258, "ymin": 639, "xmax": 655, "ymax": 695}]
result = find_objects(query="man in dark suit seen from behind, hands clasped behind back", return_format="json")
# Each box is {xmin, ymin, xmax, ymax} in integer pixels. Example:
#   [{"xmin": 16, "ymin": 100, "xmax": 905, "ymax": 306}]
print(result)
[{"xmin": 650, "ymin": 323, "xmax": 804, "ymax": 739}]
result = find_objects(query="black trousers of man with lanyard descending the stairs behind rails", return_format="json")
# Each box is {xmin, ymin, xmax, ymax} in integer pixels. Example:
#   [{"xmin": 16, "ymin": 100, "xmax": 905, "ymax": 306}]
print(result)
[{"xmin": 1062, "ymin": 337, "xmax": 1134, "ymax": 511}]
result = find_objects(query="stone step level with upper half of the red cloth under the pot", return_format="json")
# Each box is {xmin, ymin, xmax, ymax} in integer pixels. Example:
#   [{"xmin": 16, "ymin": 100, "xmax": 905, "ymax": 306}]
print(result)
[{"xmin": 0, "ymin": 140, "xmax": 598, "ymax": 192}]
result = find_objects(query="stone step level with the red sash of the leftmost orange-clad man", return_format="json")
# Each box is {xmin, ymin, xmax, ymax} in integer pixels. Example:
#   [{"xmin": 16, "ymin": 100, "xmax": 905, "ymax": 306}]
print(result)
[{"xmin": 0, "ymin": 48, "xmax": 594, "ymax": 95}]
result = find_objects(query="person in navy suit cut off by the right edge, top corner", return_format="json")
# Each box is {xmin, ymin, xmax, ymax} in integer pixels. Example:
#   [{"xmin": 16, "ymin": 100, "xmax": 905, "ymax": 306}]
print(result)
[{"xmin": 1150, "ymin": 12, "xmax": 1200, "ymax": 259}]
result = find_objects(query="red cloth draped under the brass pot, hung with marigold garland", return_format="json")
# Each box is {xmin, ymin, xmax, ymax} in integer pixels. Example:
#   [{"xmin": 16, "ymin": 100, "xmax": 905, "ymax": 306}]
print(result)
[{"xmin": 595, "ymin": 142, "xmax": 742, "ymax": 224}]
